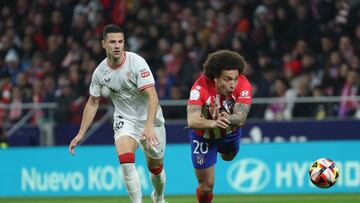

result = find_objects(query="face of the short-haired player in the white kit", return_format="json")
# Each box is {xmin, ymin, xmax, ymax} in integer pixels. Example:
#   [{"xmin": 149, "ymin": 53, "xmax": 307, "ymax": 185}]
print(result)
[{"xmin": 102, "ymin": 33, "xmax": 125, "ymax": 59}]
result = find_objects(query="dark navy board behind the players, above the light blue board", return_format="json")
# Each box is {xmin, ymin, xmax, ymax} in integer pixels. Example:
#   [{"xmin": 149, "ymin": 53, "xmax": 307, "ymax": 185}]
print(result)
[{"xmin": 8, "ymin": 120, "xmax": 360, "ymax": 146}]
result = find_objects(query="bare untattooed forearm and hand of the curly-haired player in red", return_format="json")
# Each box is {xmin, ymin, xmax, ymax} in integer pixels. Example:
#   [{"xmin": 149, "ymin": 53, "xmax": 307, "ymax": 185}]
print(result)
[{"xmin": 187, "ymin": 105, "xmax": 230, "ymax": 129}]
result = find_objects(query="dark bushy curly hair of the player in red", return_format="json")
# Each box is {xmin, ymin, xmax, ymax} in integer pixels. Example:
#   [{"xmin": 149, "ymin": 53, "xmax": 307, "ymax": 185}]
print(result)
[{"xmin": 204, "ymin": 50, "xmax": 245, "ymax": 80}]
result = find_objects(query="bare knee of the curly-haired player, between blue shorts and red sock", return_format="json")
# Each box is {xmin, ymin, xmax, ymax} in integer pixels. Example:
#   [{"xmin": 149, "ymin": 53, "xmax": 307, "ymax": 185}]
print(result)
[{"xmin": 195, "ymin": 165, "xmax": 215, "ymax": 191}]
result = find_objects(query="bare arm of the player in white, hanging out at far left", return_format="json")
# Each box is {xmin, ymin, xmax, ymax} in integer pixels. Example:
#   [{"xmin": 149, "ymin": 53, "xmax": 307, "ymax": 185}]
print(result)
[{"xmin": 69, "ymin": 97, "xmax": 99, "ymax": 155}]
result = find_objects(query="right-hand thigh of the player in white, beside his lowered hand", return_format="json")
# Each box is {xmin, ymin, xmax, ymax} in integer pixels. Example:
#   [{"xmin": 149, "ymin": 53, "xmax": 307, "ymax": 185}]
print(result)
[{"xmin": 140, "ymin": 125, "xmax": 166, "ymax": 161}]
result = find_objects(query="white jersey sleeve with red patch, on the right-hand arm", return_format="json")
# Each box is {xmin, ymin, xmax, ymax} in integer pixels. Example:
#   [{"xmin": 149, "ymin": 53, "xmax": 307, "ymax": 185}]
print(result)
[{"xmin": 135, "ymin": 57, "xmax": 155, "ymax": 91}]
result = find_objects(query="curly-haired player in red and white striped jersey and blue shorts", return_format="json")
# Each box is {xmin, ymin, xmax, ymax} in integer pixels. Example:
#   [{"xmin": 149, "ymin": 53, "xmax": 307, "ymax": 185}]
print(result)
[{"xmin": 187, "ymin": 50, "xmax": 252, "ymax": 203}]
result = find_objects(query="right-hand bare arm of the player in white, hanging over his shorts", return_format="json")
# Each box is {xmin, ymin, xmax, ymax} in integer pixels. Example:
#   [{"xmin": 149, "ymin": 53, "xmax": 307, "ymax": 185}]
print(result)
[{"xmin": 142, "ymin": 87, "xmax": 159, "ymax": 147}]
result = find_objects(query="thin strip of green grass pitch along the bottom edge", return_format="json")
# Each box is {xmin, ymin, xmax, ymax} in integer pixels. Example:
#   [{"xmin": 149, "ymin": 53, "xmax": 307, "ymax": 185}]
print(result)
[{"xmin": 0, "ymin": 193, "xmax": 360, "ymax": 203}]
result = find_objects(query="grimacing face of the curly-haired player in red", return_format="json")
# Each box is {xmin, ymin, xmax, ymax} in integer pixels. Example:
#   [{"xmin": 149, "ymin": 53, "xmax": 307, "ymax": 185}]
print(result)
[{"xmin": 215, "ymin": 70, "xmax": 239, "ymax": 95}]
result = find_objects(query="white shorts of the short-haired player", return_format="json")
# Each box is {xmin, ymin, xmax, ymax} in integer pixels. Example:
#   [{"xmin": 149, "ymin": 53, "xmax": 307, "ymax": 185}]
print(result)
[{"xmin": 113, "ymin": 119, "xmax": 166, "ymax": 159}]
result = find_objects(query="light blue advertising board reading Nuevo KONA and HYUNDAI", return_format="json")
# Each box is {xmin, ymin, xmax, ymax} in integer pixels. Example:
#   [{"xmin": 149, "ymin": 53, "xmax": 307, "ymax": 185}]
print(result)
[{"xmin": 0, "ymin": 140, "xmax": 360, "ymax": 197}]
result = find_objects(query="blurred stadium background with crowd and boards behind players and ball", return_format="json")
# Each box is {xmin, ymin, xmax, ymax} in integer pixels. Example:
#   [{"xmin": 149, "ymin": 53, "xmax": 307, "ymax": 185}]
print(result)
[{"xmin": 0, "ymin": 0, "xmax": 360, "ymax": 202}]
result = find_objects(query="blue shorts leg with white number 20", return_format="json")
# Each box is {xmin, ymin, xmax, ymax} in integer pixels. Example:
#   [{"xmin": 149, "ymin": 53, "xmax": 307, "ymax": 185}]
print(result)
[{"xmin": 189, "ymin": 130, "xmax": 217, "ymax": 169}]
